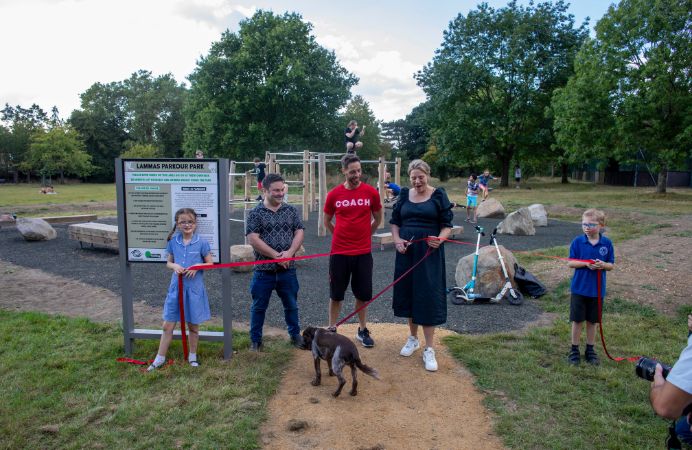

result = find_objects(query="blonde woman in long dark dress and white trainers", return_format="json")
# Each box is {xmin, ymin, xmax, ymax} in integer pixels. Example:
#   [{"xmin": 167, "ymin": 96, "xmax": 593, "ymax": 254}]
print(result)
[{"xmin": 389, "ymin": 159, "xmax": 453, "ymax": 372}]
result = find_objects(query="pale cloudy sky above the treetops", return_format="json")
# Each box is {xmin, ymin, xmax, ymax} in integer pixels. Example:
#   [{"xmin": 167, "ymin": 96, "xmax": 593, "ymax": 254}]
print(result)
[{"xmin": 0, "ymin": 0, "xmax": 611, "ymax": 121}]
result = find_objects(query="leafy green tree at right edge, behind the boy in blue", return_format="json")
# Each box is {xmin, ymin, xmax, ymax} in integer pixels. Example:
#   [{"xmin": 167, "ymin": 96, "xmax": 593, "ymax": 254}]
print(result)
[{"xmin": 553, "ymin": 0, "xmax": 692, "ymax": 193}]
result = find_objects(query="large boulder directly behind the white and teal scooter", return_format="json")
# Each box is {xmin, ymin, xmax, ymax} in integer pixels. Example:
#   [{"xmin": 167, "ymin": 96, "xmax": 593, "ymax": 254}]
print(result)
[{"xmin": 454, "ymin": 245, "xmax": 517, "ymax": 297}]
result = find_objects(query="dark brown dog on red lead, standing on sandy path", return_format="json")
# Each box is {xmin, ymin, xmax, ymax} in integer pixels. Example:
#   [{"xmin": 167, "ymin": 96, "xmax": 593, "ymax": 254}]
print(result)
[{"xmin": 303, "ymin": 327, "xmax": 380, "ymax": 397}]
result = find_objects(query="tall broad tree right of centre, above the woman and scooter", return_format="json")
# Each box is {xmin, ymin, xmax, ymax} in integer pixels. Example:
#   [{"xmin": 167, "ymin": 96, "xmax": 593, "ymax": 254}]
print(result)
[{"xmin": 416, "ymin": 1, "xmax": 587, "ymax": 186}]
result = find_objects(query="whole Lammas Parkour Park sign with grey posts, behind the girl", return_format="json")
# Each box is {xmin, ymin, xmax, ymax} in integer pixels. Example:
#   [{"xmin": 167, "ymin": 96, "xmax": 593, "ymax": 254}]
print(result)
[{"xmin": 115, "ymin": 158, "xmax": 233, "ymax": 359}]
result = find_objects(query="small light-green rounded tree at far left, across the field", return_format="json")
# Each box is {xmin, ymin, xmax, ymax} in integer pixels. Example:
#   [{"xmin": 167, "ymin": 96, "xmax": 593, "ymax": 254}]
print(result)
[{"xmin": 23, "ymin": 126, "xmax": 93, "ymax": 184}]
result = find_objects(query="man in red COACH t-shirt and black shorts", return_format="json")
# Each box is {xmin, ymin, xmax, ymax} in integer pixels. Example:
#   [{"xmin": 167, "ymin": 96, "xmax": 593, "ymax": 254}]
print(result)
[{"xmin": 324, "ymin": 154, "xmax": 382, "ymax": 347}]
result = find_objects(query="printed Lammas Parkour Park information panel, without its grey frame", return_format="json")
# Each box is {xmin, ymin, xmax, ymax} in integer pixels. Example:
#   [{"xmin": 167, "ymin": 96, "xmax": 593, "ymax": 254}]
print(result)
[{"xmin": 122, "ymin": 159, "xmax": 220, "ymax": 263}]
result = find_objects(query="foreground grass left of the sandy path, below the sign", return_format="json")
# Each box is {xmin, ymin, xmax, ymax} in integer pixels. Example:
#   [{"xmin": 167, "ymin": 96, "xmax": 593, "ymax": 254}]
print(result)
[{"xmin": 0, "ymin": 311, "xmax": 290, "ymax": 449}]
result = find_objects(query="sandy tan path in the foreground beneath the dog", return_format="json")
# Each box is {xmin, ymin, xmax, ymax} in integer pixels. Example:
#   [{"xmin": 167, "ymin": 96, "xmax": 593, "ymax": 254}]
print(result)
[{"xmin": 262, "ymin": 324, "xmax": 503, "ymax": 450}]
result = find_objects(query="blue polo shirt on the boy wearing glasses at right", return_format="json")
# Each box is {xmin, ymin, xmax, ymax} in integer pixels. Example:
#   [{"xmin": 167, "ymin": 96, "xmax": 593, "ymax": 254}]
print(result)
[{"xmin": 569, "ymin": 234, "xmax": 615, "ymax": 298}]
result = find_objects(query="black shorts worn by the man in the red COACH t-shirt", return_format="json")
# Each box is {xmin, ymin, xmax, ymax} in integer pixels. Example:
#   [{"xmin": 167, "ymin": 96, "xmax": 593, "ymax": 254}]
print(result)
[{"xmin": 329, "ymin": 253, "xmax": 372, "ymax": 302}]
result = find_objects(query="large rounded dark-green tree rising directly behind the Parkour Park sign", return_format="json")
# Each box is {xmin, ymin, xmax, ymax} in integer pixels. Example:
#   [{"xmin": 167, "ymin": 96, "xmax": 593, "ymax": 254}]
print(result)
[{"xmin": 184, "ymin": 11, "xmax": 357, "ymax": 160}]
